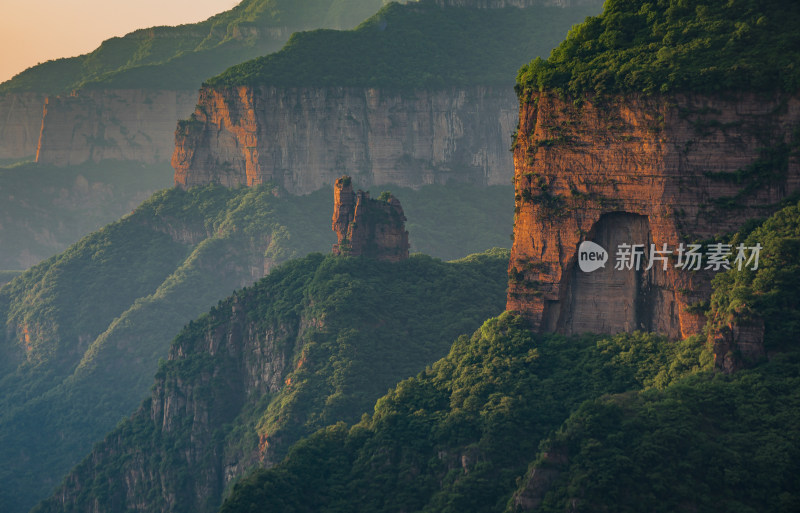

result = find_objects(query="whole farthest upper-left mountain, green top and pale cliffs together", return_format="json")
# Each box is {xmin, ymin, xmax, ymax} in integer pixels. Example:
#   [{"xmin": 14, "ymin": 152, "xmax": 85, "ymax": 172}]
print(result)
[{"xmin": 0, "ymin": 0, "xmax": 383, "ymax": 166}]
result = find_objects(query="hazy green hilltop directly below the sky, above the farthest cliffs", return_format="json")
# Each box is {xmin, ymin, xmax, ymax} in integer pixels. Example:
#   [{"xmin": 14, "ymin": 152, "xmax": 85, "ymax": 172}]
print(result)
[{"xmin": 0, "ymin": 0, "xmax": 383, "ymax": 94}]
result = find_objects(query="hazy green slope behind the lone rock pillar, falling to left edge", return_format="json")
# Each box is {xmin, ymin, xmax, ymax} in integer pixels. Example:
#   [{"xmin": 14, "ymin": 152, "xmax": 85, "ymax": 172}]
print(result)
[{"xmin": 0, "ymin": 182, "xmax": 513, "ymax": 511}]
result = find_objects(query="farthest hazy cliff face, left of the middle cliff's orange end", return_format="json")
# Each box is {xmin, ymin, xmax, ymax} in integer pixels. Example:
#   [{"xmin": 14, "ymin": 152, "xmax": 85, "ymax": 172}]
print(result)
[{"xmin": 36, "ymin": 89, "xmax": 197, "ymax": 166}]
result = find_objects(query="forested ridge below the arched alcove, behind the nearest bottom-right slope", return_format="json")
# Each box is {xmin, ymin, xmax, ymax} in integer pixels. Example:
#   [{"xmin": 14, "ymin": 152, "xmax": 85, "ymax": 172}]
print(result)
[{"xmin": 211, "ymin": 313, "xmax": 708, "ymax": 513}]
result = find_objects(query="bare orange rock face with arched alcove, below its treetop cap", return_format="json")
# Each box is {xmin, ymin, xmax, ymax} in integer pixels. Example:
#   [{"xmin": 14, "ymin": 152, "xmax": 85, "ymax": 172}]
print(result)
[{"xmin": 507, "ymin": 93, "xmax": 800, "ymax": 337}]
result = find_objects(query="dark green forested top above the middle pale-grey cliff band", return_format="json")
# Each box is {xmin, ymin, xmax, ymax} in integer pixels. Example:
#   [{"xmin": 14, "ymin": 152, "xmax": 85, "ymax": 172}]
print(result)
[{"xmin": 206, "ymin": 0, "xmax": 600, "ymax": 89}]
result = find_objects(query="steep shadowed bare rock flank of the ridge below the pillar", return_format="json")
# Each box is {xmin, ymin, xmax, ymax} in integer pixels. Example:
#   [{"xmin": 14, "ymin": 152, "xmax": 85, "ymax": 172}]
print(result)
[{"xmin": 32, "ymin": 286, "xmax": 299, "ymax": 513}]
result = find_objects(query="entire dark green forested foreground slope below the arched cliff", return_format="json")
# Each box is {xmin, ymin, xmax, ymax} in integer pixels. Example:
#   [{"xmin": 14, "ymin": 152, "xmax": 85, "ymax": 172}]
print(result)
[{"xmin": 216, "ymin": 205, "xmax": 800, "ymax": 513}]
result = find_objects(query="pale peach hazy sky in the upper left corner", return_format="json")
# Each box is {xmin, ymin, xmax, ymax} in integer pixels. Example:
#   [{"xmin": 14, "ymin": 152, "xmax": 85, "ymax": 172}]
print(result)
[{"xmin": 0, "ymin": 0, "xmax": 239, "ymax": 82}]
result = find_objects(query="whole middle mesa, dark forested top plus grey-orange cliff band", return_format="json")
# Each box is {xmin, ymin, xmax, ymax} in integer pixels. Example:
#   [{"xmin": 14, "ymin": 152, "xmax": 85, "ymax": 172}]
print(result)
[{"xmin": 172, "ymin": 1, "xmax": 599, "ymax": 194}]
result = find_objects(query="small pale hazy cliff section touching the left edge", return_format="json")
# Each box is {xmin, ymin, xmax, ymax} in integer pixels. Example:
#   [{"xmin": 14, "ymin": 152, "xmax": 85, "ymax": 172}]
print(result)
[{"xmin": 0, "ymin": 93, "xmax": 45, "ymax": 160}]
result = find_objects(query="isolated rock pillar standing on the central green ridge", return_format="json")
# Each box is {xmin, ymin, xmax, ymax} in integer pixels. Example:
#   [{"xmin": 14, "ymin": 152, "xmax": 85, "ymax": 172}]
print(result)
[{"xmin": 332, "ymin": 176, "xmax": 409, "ymax": 262}]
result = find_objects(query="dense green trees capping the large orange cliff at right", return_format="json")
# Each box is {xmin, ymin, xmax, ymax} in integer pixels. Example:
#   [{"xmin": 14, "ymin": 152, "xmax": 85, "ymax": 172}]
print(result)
[{"xmin": 517, "ymin": 0, "xmax": 800, "ymax": 97}]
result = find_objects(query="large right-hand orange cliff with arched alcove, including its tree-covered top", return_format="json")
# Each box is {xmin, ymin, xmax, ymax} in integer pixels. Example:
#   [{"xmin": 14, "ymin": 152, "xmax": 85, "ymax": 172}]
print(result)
[{"xmin": 507, "ymin": 0, "xmax": 800, "ymax": 355}]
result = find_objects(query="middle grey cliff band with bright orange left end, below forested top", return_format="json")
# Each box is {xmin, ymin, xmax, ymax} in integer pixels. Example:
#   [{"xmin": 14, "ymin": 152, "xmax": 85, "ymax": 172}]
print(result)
[{"xmin": 172, "ymin": 86, "xmax": 517, "ymax": 194}]
